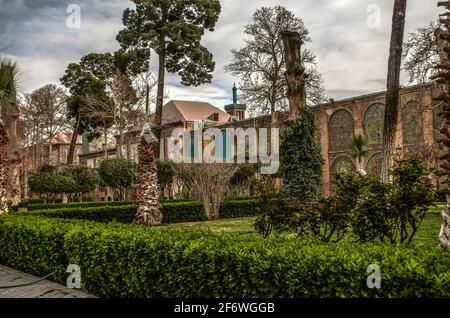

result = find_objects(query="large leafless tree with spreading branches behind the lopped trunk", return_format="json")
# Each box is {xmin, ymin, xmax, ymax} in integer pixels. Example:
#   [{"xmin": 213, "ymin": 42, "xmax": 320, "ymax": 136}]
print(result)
[{"xmin": 225, "ymin": 6, "xmax": 325, "ymax": 120}]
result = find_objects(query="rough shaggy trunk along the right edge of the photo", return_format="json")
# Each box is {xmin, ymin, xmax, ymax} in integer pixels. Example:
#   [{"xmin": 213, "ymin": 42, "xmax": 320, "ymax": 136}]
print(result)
[{"xmin": 432, "ymin": 1, "xmax": 450, "ymax": 249}]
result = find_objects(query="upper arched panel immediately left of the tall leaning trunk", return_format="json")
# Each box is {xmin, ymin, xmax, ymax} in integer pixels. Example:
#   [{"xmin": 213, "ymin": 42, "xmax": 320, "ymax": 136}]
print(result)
[{"xmin": 364, "ymin": 103, "xmax": 384, "ymax": 145}]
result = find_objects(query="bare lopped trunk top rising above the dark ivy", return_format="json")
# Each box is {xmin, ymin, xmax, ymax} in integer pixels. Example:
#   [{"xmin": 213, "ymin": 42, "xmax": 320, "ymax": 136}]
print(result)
[{"xmin": 281, "ymin": 32, "xmax": 306, "ymax": 120}]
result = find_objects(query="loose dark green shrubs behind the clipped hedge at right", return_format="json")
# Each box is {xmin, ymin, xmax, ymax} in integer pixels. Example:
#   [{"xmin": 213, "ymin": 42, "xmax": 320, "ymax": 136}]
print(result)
[{"xmin": 255, "ymin": 159, "xmax": 435, "ymax": 244}]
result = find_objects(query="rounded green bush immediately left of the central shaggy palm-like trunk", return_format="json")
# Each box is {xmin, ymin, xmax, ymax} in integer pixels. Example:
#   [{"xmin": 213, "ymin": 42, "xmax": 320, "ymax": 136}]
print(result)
[{"xmin": 97, "ymin": 158, "xmax": 137, "ymax": 190}]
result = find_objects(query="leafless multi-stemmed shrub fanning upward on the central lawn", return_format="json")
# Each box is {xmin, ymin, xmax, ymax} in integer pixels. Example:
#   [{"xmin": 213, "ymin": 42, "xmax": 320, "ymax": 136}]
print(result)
[{"xmin": 177, "ymin": 163, "xmax": 237, "ymax": 220}]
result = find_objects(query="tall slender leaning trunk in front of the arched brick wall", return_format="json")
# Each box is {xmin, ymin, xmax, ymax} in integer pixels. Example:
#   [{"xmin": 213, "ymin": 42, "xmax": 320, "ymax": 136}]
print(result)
[{"xmin": 381, "ymin": 0, "xmax": 407, "ymax": 183}]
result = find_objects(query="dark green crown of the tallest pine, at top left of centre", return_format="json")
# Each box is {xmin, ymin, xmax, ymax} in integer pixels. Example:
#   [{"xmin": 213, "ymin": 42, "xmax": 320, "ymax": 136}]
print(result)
[{"xmin": 117, "ymin": 0, "xmax": 220, "ymax": 86}]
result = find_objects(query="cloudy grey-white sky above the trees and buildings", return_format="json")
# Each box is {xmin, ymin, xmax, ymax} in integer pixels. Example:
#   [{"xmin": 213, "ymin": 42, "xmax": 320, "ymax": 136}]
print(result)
[{"xmin": 0, "ymin": 0, "xmax": 439, "ymax": 107}]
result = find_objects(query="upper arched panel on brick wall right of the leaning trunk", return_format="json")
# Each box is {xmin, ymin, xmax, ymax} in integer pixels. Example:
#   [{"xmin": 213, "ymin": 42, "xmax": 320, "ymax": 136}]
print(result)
[{"xmin": 402, "ymin": 101, "xmax": 423, "ymax": 144}]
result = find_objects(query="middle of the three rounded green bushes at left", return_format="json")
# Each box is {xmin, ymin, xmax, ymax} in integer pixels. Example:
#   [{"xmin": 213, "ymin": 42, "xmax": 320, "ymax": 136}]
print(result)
[{"xmin": 60, "ymin": 165, "xmax": 99, "ymax": 193}]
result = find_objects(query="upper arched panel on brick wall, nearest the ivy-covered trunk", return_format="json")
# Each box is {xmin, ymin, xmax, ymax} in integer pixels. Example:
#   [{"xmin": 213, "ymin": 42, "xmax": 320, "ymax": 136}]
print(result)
[{"xmin": 328, "ymin": 109, "xmax": 355, "ymax": 151}]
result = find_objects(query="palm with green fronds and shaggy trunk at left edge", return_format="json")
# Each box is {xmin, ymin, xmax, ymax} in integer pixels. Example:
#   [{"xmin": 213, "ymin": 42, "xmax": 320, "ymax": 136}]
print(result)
[{"xmin": 0, "ymin": 57, "xmax": 17, "ymax": 214}]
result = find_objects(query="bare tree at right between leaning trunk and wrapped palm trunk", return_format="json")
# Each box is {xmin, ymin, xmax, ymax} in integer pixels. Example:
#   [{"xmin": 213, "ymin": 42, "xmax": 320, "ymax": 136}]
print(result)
[{"xmin": 403, "ymin": 22, "xmax": 439, "ymax": 84}]
